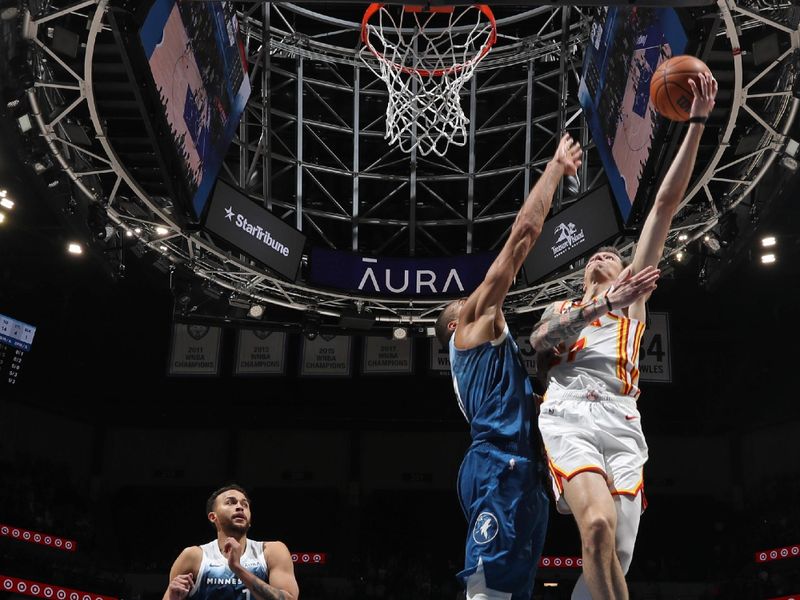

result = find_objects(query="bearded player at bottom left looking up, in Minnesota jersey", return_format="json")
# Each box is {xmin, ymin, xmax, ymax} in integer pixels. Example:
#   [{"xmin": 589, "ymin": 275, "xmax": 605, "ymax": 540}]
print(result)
[{"xmin": 163, "ymin": 484, "xmax": 300, "ymax": 600}]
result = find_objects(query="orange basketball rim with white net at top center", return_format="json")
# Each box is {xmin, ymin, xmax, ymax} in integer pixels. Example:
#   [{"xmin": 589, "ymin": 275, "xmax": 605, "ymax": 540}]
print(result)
[{"xmin": 360, "ymin": 2, "xmax": 497, "ymax": 156}]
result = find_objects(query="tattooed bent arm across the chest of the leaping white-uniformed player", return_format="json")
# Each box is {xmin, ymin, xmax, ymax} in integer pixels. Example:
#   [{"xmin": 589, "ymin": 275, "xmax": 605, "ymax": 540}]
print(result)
[{"xmin": 531, "ymin": 265, "xmax": 661, "ymax": 352}]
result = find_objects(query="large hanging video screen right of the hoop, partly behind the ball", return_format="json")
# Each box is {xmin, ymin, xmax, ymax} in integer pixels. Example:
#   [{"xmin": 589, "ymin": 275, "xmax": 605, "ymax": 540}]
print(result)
[{"xmin": 578, "ymin": 7, "xmax": 687, "ymax": 223}]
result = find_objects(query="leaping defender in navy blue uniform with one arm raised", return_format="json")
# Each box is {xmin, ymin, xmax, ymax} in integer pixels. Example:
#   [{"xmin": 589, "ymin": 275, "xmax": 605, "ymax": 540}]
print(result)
[{"xmin": 436, "ymin": 135, "xmax": 582, "ymax": 600}]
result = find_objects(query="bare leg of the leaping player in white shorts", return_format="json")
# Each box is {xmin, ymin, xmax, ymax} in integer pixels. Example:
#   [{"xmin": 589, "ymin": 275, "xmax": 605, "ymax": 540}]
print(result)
[{"xmin": 564, "ymin": 471, "xmax": 628, "ymax": 600}]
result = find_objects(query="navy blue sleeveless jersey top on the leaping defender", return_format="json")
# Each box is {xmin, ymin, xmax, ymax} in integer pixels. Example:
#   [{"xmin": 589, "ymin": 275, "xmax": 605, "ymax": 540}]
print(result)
[{"xmin": 450, "ymin": 325, "xmax": 535, "ymax": 454}]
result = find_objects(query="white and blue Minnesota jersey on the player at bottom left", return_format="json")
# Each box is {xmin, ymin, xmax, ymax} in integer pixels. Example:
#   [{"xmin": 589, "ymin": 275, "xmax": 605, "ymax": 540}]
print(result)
[{"xmin": 189, "ymin": 540, "xmax": 269, "ymax": 600}]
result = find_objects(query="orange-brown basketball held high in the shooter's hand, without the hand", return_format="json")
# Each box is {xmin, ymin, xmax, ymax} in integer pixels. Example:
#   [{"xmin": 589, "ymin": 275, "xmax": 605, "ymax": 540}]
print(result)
[{"xmin": 650, "ymin": 55, "xmax": 711, "ymax": 121}]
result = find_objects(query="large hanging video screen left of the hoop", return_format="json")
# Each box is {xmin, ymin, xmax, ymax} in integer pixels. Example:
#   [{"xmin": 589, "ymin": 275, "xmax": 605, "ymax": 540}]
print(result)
[{"xmin": 139, "ymin": 0, "xmax": 250, "ymax": 219}]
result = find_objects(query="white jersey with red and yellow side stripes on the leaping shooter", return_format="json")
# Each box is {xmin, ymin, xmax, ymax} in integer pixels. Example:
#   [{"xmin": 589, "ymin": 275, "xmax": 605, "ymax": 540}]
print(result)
[{"xmin": 548, "ymin": 301, "xmax": 644, "ymax": 398}]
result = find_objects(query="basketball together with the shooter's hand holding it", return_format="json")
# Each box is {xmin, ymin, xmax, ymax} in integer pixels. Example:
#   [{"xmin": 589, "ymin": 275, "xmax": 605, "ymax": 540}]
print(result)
[{"xmin": 650, "ymin": 55, "xmax": 717, "ymax": 121}]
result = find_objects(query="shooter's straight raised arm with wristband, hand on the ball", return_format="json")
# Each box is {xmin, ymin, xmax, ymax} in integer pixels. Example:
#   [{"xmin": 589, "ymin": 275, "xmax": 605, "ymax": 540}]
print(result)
[{"xmin": 631, "ymin": 73, "xmax": 717, "ymax": 273}]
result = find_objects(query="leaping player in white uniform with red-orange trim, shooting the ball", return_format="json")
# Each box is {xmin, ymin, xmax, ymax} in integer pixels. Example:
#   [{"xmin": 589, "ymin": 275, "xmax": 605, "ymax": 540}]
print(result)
[{"xmin": 531, "ymin": 74, "xmax": 717, "ymax": 600}]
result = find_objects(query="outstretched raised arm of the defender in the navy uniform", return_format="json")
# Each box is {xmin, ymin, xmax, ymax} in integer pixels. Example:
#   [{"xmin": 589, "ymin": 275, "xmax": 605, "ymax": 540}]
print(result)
[{"xmin": 456, "ymin": 134, "xmax": 583, "ymax": 347}]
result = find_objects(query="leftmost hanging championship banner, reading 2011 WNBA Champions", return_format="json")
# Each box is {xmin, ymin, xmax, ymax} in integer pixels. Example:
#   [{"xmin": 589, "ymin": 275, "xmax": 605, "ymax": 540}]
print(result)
[{"xmin": 169, "ymin": 323, "xmax": 222, "ymax": 375}]
